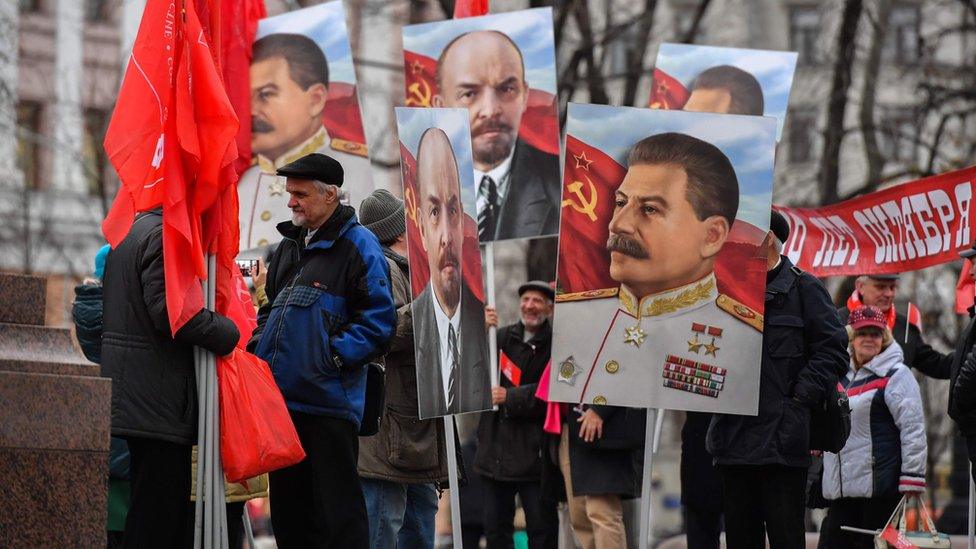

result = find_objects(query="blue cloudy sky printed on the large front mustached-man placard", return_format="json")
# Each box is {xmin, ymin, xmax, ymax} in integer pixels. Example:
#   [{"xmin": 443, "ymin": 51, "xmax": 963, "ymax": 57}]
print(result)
[{"xmin": 566, "ymin": 103, "xmax": 776, "ymax": 231}]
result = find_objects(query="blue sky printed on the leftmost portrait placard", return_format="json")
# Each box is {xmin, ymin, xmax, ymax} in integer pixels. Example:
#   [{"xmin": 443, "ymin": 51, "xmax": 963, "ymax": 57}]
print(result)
[{"xmin": 257, "ymin": 0, "xmax": 356, "ymax": 84}]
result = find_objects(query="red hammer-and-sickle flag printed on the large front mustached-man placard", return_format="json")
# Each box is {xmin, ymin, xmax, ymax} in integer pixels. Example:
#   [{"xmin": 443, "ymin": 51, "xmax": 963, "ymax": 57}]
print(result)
[{"xmin": 557, "ymin": 135, "xmax": 766, "ymax": 312}]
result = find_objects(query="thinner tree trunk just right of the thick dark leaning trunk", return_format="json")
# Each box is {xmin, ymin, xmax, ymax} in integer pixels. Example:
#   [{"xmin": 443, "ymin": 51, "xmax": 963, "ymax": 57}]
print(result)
[{"xmin": 859, "ymin": 0, "xmax": 891, "ymax": 189}]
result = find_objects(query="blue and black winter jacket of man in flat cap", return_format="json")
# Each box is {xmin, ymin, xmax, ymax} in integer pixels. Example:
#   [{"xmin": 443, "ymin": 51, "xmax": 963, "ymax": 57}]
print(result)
[{"xmin": 248, "ymin": 205, "xmax": 396, "ymax": 428}]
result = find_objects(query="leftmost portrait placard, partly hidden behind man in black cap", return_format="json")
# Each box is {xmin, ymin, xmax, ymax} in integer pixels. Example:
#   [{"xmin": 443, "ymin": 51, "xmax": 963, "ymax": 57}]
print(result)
[{"xmin": 237, "ymin": 0, "xmax": 373, "ymax": 252}]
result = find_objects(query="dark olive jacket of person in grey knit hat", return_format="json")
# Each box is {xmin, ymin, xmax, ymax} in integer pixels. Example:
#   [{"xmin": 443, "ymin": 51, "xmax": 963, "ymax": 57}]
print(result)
[{"xmin": 359, "ymin": 248, "xmax": 447, "ymax": 483}]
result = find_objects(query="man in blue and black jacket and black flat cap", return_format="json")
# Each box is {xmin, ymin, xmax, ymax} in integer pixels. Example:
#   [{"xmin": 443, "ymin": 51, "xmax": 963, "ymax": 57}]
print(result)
[{"xmin": 248, "ymin": 153, "xmax": 396, "ymax": 549}]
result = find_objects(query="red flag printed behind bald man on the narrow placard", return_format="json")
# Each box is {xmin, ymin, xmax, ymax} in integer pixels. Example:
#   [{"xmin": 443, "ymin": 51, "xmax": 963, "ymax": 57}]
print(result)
[{"xmin": 400, "ymin": 143, "xmax": 485, "ymax": 302}]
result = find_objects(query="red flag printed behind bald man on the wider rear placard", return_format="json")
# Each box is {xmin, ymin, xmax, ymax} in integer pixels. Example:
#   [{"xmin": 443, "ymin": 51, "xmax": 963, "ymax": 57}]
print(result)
[{"xmin": 402, "ymin": 50, "xmax": 559, "ymax": 154}]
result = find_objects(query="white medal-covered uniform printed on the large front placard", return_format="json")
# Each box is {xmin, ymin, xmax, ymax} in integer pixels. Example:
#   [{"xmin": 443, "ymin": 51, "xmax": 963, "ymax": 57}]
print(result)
[{"xmin": 550, "ymin": 273, "xmax": 763, "ymax": 414}]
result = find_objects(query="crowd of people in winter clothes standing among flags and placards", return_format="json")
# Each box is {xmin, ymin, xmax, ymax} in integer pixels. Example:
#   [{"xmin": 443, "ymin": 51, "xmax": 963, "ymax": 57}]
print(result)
[{"xmin": 75, "ymin": 146, "xmax": 976, "ymax": 549}]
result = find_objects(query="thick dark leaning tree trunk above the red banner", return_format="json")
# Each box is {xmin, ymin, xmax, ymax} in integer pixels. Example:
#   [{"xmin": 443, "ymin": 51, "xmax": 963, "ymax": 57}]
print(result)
[{"xmin": 819, "ymin": 0, "xmax": 864, "ymax": 204}]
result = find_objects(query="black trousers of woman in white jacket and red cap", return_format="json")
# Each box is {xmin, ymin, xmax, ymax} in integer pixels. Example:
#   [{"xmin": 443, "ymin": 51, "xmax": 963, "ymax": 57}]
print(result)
[{"xmin": 817, "ymin": 496, "xmax": 901, "ymax": 549}]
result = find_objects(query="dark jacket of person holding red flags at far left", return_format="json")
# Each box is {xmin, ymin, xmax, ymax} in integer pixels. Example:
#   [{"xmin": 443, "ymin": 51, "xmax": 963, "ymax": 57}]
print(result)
[{"xmin": 102, "ymin": 210, "xmax": 240, "ymax": 444}]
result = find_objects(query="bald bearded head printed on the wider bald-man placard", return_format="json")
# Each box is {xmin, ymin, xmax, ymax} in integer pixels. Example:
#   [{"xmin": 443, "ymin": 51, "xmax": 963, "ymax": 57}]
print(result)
[{"xmin": 433, "ymin": 31, "xmax": 529, "ymax": 171}]
